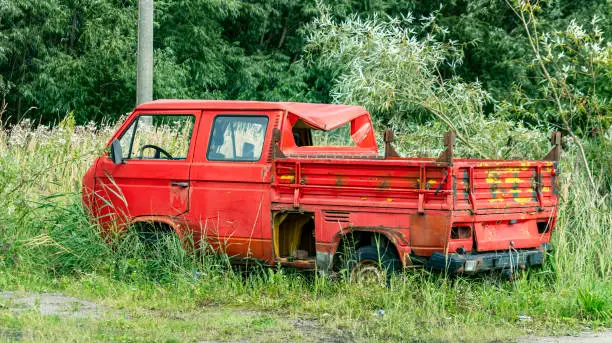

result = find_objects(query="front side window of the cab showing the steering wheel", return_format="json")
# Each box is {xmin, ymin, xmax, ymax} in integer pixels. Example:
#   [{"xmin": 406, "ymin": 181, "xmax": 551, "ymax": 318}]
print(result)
[{"xmin": 119, "ymin": 114, "xmax": 195, "ymax": 160}]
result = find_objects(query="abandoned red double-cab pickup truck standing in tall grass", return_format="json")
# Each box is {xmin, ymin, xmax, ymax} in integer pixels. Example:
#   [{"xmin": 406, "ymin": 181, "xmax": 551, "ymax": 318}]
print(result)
[{"xmin": 83, "ymin": 100, "xmax": 560, "ymax": 277}]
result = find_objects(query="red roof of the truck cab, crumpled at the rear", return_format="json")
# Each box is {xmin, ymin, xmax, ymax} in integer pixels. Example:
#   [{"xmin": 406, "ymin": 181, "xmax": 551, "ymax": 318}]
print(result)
[{"xmin": 136, "ymin": 100, "xmax": 368, "ymax": 131}]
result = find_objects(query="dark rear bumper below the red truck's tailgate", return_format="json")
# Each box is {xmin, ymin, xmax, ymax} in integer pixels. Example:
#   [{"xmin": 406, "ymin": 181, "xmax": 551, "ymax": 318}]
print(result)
[{"xmin": 425, "ymin": 243, "xmax": 551, "ymax": 273}]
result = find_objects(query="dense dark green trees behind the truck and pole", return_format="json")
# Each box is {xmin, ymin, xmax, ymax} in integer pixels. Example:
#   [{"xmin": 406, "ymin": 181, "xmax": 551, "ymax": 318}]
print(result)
[{"xmin": 0, "ymin": 0, "xmax": 612, "ymax": 129}]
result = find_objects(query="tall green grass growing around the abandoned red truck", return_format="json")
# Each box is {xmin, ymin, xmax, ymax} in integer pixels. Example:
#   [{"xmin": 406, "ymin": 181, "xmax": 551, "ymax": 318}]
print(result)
[{"xmin": 0, "ymin": 117, "xmax": 612, "ymax": 342}]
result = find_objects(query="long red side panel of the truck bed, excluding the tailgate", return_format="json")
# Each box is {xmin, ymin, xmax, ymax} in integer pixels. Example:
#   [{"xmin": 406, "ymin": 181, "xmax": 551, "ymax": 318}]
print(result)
[{"xmin": 272, "ymin": 159, "xmax": 453, "ymax": 213}]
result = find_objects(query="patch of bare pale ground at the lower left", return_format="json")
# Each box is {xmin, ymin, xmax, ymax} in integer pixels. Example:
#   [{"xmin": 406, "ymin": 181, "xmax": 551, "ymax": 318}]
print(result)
[{"xmin": 0, "ymin": 292, "xmax": 106, "ymax": 318}]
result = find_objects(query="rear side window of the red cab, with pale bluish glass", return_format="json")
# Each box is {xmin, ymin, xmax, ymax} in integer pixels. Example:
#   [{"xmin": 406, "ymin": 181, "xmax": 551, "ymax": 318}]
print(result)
[{"xmin": 206, "ymin": 115, "xmax": 268, "ymax": 162}]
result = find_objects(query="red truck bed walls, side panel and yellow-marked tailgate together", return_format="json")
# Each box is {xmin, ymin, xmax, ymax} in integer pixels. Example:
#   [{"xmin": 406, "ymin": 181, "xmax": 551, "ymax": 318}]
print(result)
[{"xmin": 274, "ymin": 158, "xmax": 556, "ymax": 214}]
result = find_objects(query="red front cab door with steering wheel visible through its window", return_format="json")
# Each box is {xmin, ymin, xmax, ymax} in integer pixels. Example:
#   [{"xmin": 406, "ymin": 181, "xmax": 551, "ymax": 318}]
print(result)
[{"xmin": 95, "ymin": 111, "xmax": 200, "ymax": 227}]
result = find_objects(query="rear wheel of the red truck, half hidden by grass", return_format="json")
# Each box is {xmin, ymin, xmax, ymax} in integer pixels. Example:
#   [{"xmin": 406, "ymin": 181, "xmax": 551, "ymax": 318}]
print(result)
[{"xmin": 344, "ymin": 245, "xmax": 401, "ymax": 284}]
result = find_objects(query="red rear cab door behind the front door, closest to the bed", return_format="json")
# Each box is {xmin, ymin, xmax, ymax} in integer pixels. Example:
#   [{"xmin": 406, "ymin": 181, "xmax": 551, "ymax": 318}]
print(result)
[{"xmin": 189, "ymin": 111, "xmax": 280, "ymax": 260}]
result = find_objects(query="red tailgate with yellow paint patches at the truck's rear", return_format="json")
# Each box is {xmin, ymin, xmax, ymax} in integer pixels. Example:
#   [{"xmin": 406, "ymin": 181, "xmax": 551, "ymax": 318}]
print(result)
[{"xmin": 454, "ymin": 160, "xmax": 557, "ymax": 213}]
